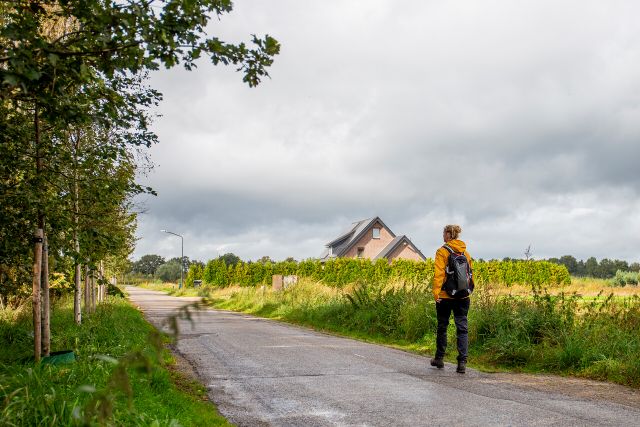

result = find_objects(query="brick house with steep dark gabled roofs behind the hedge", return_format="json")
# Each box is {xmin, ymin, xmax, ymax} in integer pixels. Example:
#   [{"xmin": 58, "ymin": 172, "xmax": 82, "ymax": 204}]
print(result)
[{"xmin": 320, "ymin": 217, "xmax": 425, "ymax": 261}]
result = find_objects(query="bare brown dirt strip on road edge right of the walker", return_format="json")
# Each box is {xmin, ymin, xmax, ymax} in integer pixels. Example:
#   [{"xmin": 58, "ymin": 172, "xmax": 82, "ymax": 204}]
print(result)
[{"xmin": 481, "ymin": 373, "xmax": 640, "ymax": 409}]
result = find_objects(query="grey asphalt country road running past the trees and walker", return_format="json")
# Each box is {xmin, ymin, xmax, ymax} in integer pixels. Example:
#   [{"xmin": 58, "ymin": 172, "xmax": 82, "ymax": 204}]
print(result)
[{"xmin": 126, "ymin": 287, "xmax": 640, "ymax": 427}]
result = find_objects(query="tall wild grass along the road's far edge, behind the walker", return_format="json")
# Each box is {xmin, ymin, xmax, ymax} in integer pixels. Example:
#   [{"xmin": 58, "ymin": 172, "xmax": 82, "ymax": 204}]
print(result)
[{"xmin": 210, "ymin": 280, "xmax": 640, "ymax": 387}]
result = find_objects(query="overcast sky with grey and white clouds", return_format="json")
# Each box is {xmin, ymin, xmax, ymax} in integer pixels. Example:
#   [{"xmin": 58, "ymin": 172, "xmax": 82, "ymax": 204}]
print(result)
[{"xmin": 133, "ymin": 0, "xmax": 640, "ymax": 261}]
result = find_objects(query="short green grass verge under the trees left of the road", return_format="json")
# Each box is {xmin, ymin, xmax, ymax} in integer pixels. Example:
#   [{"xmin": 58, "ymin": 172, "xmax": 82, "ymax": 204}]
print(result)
[{"xmin": 0, "ymin": 297, "xmax": 229, "ymax": 426}]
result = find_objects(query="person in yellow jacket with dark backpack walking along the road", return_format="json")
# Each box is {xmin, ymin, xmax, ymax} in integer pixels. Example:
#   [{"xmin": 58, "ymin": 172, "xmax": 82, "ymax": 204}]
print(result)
[{"xmin": 431, "ymin": 225, "xmax": 473, "ymax": 374}]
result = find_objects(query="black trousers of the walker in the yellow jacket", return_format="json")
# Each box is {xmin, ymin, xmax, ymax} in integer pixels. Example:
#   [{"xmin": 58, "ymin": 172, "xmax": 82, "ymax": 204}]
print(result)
[{"xmin": 436, "ymin": 298, "xmax": 471, "ymax": 362}]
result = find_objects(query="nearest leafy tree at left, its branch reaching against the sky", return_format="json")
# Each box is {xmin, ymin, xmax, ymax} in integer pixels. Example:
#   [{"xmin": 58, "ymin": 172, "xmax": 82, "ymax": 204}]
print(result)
[{"xmin": 0, "ymin": 0, "xmax": 279, "ymax": 360}]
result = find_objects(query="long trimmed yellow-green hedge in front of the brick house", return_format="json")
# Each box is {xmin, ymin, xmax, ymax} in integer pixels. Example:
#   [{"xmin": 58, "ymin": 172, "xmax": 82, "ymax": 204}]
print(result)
[{"xmin": 187, "ymin": 258, "xmax": 571, "ymax": 287}]
